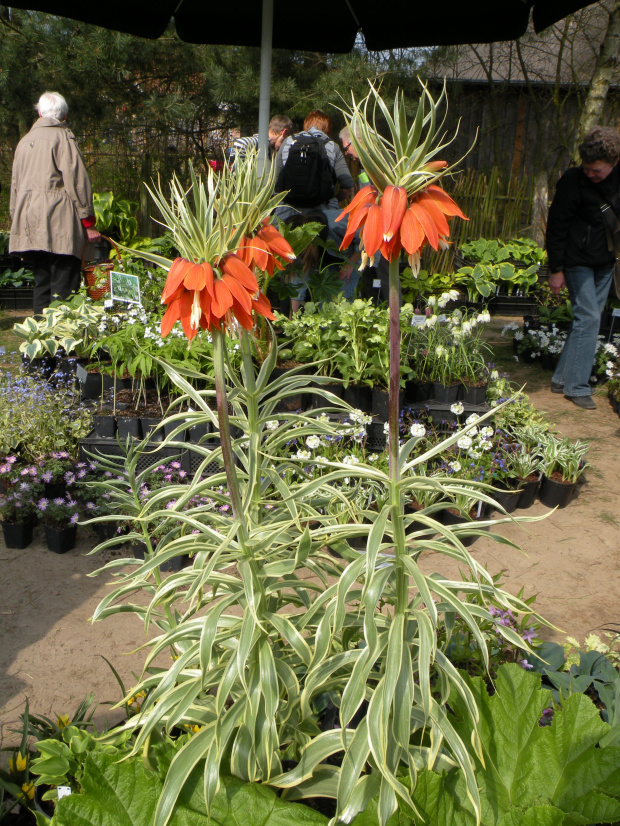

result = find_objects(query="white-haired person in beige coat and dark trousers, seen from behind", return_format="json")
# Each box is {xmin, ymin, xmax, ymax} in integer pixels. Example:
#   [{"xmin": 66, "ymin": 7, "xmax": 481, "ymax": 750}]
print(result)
[{"xmin": 9, "ymin": 92, "xmax": 101, "ymax": 315}]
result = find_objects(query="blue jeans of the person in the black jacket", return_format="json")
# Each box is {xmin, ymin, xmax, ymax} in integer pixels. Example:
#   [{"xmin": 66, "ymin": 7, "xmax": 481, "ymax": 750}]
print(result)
[{"xmin": 553, "ymin": 264, "xmax": 614, "ymax": 396}]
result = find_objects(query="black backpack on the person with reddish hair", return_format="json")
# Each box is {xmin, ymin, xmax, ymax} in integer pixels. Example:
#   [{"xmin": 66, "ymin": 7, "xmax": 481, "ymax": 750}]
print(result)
[{"xmin": 275, "ymin": 135, "xmax": 334, "ymax": 207}]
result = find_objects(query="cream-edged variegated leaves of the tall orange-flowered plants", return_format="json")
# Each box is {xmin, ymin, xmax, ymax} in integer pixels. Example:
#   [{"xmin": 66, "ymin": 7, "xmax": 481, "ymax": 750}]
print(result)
[{"xmin": 83, "ymin": 344, "xmax": 548, "ymax": 826}]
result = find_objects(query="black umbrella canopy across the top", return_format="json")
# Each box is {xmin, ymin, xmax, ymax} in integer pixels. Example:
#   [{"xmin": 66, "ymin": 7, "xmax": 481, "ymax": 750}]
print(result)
[{"xmin": 6, "ymin": 0, "xmax": 591, "ymax": 53}]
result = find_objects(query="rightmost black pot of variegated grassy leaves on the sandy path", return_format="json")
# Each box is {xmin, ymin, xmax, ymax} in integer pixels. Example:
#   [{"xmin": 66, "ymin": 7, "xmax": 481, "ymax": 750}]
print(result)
[{"xmin": 539, "ymin": 433, "xmax": 590, "ymax": 508}]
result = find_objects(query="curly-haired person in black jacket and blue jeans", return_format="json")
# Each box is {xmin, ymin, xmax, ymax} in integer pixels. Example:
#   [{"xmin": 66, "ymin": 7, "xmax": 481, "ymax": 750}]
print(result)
[{"xmin": 547, "ymin": 126, "xmax": 620, "ymax": 410}]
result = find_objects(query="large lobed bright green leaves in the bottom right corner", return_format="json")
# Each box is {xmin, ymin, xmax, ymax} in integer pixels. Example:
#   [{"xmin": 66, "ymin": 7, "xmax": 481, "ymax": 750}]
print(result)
[{"xmin": 400, "ymin": 665, "xmax": 620, "ymax": 826}]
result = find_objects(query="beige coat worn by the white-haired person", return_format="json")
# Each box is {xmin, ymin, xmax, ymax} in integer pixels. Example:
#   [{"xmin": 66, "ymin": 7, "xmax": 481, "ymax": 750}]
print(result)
[{"xmin": 9, "ymin": 118, "xmax": 95, "ymax": 258}]
